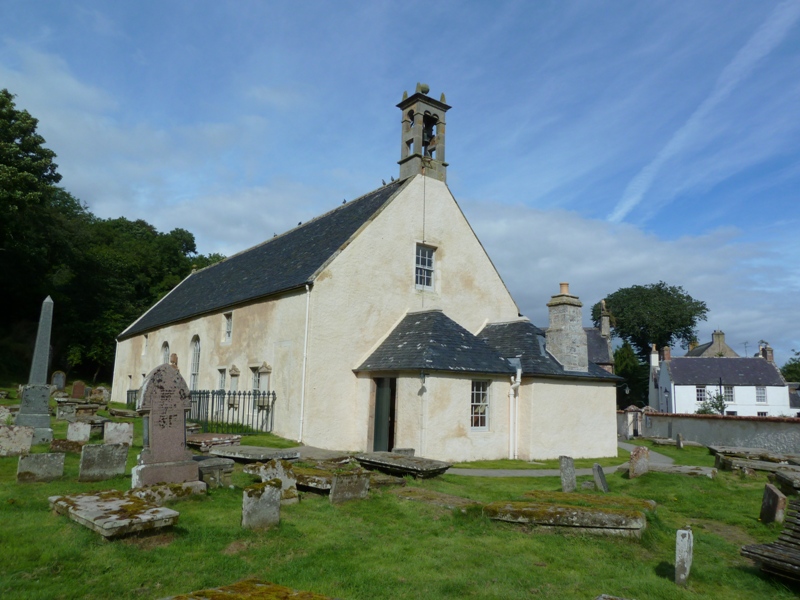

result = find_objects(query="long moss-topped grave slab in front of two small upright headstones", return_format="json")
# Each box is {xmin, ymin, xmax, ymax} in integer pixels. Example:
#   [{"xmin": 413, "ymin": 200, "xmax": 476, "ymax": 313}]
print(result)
[{"xmin": 483, "ymin": 502, "xmax": 647, "ymax": 538}]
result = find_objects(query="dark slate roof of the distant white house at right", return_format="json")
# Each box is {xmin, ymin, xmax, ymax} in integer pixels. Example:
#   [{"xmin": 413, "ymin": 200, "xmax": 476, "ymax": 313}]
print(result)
[{"xmin": 665, "ymin": 356, "xmax": 786, "ymax": 386}]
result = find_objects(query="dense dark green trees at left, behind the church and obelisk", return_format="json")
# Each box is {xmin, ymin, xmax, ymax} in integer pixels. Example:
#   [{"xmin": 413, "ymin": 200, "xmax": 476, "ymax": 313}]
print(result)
[{"xmin": 0, "ymin": 90, "xmax": 224, "ymax": 381}]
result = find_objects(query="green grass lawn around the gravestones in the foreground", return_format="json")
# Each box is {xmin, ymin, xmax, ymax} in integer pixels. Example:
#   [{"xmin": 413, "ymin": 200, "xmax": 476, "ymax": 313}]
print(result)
[{"xmin": 0, "ymin": 420, "xmax": 800, "ymax": 600}]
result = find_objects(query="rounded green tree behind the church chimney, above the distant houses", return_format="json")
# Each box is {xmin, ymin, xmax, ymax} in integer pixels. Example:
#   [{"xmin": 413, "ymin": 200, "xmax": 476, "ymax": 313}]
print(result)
[{"xmin": 592, "ymin": 281, "xmax": 708, "ymax": 361}]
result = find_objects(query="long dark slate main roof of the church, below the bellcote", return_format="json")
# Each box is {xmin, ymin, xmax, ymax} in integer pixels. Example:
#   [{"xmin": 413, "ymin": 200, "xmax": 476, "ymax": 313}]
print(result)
[{"xmin": 119, "ymin": 180, "xmax": 408, "ymax": 339}]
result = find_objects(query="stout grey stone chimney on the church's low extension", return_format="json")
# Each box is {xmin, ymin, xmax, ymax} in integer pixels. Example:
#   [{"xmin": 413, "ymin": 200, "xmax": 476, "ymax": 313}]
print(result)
[{"xmin": 546, "ymin": 283, "xmax": 589, "ymax": 372}]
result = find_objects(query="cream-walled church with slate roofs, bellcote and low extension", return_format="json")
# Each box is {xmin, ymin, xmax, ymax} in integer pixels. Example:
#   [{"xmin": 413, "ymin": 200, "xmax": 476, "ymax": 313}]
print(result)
[{"xmin": 112, "ymin": 87, "xmax": 618, "ymax": 460}]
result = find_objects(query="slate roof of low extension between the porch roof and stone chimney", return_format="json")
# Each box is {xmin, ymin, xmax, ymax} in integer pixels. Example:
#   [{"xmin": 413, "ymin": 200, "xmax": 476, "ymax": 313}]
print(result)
[{"xmin": 478, "ymin": 320, "xmax": 619, "ymax": 380}]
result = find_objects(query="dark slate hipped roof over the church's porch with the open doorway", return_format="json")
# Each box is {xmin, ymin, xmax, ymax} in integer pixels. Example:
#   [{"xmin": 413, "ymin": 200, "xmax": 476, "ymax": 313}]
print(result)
[{"xmin": 356, "ymin": 310, "xmax": 514, "ymax": 374}]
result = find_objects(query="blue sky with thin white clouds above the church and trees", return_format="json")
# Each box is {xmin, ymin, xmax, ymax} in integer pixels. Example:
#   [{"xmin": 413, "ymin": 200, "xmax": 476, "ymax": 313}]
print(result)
[{"xmin": 0, "ymin": 0, "xmax": 800, "ymax": 363}]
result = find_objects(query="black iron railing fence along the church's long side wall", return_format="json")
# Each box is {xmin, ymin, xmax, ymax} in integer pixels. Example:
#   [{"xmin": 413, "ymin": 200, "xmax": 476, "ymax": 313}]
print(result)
[{"xmin": 126, "ymin": 390, "xmax": 277, "ymax": 435}]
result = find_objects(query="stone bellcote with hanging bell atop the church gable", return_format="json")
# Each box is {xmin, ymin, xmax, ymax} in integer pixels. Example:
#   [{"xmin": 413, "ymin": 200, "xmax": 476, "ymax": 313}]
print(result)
[{"xmin": 397, "ymin": 83, "xmax": 450, "ymax": 181}]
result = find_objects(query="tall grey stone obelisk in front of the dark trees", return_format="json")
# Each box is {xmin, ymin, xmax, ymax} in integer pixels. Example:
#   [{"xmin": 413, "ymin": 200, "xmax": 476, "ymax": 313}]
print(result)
[{"xmin": 16, "ymin": 296, "xmax": 53, "ymax": 444}]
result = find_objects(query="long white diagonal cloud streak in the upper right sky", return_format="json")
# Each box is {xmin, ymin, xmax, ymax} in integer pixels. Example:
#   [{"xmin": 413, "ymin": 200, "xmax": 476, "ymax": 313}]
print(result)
[{"xmin": 608, "ymin": 0, "xmax": 800, "ymax": 222}]
